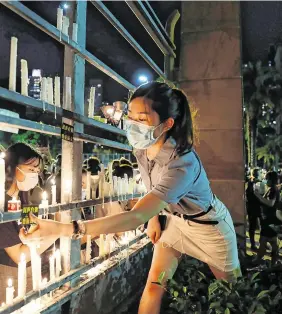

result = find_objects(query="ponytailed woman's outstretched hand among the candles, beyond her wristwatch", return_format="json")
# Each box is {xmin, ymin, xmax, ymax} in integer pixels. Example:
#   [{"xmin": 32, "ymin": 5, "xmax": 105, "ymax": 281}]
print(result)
[{"xmin": 19, "ymin": 214, "xmax": 72, "ymax": 244}]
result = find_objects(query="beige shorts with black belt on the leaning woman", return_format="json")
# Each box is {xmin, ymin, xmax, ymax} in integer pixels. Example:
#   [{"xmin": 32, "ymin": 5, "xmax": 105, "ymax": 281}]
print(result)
[{"xmin": 159, "ymin": 197, "xmax": 240, "ymax": 275}]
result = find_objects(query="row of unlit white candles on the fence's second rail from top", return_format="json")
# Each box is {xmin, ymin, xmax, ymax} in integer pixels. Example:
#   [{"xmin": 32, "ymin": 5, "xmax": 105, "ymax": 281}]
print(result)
[{"xmin": 9, "ymin": 36, "xmax": 96, "ymax": 118}]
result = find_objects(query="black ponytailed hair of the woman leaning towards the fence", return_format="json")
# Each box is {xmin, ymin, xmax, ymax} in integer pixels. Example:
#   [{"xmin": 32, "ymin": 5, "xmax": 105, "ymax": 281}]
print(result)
[{"xmin": 129, "ymin": 82, "xmax": 194, "ymax": 155}]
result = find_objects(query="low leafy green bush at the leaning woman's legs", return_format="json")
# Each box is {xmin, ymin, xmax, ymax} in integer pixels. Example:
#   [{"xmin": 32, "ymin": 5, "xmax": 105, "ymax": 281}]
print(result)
[{"xmin": 158, "ymin": 259, "xmax": 282, "ymax": 314}]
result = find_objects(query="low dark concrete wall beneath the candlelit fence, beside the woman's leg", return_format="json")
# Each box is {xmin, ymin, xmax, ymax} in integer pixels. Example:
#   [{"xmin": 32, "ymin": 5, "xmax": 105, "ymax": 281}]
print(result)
[{"xmin": 40, "ymin": 240, "xmax": 153, "ymax": 314}]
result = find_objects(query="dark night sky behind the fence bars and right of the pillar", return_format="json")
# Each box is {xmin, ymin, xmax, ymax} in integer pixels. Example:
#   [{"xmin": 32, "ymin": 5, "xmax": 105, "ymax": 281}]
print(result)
[{"xmin": 0, "ymin": 1, "xmax": 282, "ymax": 101}]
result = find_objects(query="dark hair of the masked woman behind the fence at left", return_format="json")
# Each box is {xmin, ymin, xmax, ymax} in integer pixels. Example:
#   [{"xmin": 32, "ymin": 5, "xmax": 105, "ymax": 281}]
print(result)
[{"xmin": 5, "ymin": 143, "xmax": 44, "ymax": 189}]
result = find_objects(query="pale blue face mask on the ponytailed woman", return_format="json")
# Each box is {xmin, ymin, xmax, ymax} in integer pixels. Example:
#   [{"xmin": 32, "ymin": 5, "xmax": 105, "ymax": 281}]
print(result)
[{"xmin": 125, "ymin": 120, "xmax": 163, "ymax": 149}]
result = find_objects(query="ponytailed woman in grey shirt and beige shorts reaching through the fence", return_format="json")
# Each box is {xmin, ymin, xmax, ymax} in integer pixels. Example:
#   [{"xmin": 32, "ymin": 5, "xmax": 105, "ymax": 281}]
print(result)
[{"xmin": 20, "ymin": 82, "xmax": 240, "ymax": 314}]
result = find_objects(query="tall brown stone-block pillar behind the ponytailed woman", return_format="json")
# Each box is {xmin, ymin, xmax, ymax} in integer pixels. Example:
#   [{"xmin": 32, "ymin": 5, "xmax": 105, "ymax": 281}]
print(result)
[{"xmin": 179, "ymin": 1, "xmax": 245, "ymax": 236}]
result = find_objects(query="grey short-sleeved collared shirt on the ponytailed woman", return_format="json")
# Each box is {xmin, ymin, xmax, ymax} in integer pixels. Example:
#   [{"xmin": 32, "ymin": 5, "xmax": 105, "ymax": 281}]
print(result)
[{"xmin": 135, "ymin": 138, "xmax": 213, "ymax": 215}]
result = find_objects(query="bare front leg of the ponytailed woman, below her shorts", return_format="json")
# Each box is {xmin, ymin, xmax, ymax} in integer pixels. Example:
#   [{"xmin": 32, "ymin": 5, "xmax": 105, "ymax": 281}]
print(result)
[{"xmin": 138, "ymin": 242, "xmax": 181, "ymax": 314}]
